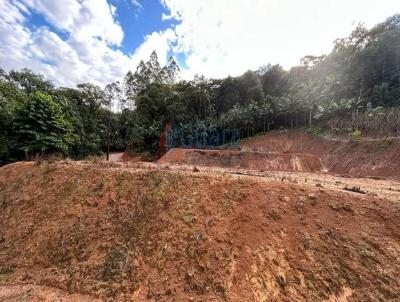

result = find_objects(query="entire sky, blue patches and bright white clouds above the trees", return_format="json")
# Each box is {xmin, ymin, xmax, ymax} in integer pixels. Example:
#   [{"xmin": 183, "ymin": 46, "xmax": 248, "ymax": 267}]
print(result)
[{"xmin": 0, "ymin": 0, "xmax": 400, "ymax": 86}]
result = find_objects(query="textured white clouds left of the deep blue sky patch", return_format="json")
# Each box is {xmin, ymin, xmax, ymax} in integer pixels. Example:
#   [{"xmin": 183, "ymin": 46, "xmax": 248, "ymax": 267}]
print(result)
[{"xmin": 0, "ymin": 0, "xmax": 175, "ymax": 86}]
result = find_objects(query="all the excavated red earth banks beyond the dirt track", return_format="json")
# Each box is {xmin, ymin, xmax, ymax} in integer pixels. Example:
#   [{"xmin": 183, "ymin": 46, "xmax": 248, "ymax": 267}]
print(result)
[{"xmin": 159, "ymin": 131, "xmax": 400, "ymax": 179}]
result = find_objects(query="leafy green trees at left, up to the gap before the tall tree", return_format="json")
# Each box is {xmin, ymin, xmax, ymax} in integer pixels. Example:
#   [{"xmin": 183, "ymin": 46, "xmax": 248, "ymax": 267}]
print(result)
[{"xmin": 0, "ymin": 69, "xmax": 125, "ymax": 163}]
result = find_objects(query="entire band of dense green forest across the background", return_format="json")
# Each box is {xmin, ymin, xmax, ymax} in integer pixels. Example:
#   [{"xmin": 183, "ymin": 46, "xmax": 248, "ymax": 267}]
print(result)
[{"xmin": 0, "ymin": 15, "xmax": 400, "ymax": 163}]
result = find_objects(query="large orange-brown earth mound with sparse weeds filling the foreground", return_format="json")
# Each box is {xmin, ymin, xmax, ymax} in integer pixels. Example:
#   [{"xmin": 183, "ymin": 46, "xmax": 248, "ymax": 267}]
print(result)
[{"xmin": 0, "ymin": 162, "xmax": 400, "ymax": 301}]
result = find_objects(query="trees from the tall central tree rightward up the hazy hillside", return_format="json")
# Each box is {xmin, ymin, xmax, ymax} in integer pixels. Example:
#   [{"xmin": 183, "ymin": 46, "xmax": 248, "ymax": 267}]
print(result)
[{"xmin": 125, "ymin": 15, "xmax": 400, "ymax": 151}]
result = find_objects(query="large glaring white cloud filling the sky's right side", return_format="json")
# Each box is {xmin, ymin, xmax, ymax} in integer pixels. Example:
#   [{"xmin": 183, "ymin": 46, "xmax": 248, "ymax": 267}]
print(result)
[{"xmin": 162, "ymin": 0, "xmax": 400, "ymax": 77}]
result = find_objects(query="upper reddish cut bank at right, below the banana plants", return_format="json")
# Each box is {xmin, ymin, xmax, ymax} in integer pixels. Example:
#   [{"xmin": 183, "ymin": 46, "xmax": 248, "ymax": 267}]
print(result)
[{"xmin": 241, "ymin": 131, "xmax": 400, "ymax": 178}]
